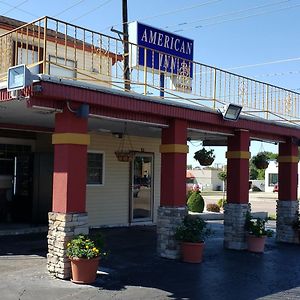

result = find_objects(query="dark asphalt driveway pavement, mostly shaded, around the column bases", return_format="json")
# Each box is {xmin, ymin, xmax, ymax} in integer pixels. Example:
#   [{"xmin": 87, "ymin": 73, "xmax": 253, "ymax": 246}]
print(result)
[{"xmin": 0, "ymin": 222, "xmax": 300, "ymax": 300}]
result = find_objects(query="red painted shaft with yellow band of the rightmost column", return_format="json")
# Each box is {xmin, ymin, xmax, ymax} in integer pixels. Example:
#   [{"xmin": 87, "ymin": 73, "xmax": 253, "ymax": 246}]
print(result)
[{"xmin": 278, "ymin": 138, "xmax": 298, "ymax": 201}]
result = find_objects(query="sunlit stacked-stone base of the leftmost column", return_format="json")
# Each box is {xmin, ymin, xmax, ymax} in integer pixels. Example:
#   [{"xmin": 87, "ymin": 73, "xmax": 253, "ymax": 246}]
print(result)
[{"xmin": 47, "ymin": 212, "xmax": 89, "ymax": 279}]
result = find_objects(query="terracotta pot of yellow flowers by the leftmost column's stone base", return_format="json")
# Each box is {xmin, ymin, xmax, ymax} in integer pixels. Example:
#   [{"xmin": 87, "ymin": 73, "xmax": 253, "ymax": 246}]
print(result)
[{"xmin": 66, "ymin": 234, "xmax": 105, "ymax": 283}]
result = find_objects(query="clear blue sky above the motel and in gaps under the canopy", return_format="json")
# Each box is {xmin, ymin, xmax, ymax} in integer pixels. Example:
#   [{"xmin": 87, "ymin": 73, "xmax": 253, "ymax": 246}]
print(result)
[{"xmin": 0, "ymin": 0, "xmax": 300, "ymax": 166}]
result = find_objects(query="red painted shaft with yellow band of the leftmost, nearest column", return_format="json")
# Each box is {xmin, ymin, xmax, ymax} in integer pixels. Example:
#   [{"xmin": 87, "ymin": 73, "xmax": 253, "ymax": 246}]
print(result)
[{"xmin": 52, "ymin": 109, "xmax": 89, "ymax": 213}]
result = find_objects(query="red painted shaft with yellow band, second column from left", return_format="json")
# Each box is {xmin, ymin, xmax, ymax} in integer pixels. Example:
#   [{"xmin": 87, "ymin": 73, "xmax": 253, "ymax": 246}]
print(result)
[{"xmin": 160, "ymin": 120, "xmax": 188, "ymax": 207}]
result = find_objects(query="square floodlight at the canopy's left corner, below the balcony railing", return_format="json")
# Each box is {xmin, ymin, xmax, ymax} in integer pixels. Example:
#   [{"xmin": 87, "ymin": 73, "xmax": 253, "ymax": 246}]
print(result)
[{"xmin": 7, "ymin": 65, "xmax": 33, "ymax": 92}]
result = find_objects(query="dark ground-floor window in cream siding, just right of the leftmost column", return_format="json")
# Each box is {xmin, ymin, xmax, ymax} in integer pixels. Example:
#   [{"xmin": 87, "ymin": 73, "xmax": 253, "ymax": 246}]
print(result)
[{"xmin": 87, "ymin": 152, "xmax": 104, "ymax": 185}]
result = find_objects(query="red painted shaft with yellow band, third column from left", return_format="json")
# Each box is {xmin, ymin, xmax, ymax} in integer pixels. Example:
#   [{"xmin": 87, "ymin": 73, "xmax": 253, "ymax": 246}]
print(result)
[{"xmin": 226, "ymin": 130, "xmax": 250, "ymax": 204}]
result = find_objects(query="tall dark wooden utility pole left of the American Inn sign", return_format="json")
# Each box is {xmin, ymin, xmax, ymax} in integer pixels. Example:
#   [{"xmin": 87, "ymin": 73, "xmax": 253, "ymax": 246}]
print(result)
[{"xmin": 122, "ymin": 0, "xmax": 130, "ymax": 91}]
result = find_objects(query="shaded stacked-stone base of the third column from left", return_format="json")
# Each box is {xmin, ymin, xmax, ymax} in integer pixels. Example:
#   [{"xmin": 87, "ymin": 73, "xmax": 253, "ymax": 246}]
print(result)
[{"xmin": 224, "ymin": 203, "xmax": 249, "ymax": 250}]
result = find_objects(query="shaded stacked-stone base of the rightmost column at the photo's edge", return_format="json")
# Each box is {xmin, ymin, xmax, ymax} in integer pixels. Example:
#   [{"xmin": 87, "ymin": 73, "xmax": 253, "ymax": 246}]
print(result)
[{"xmin": 276, "ymin": 200, "xmax": 299, "ymax": 243}]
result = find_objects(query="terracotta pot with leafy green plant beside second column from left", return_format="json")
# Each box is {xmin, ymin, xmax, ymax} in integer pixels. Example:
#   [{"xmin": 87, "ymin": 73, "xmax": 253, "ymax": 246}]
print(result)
[{"xmin": 175, "ymin": 215, "xmax": 211, "ymax": 263}]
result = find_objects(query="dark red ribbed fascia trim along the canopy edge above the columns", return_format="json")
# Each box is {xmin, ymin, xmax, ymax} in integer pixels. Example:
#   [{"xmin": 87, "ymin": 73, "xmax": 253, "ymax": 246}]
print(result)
[{"xmin": 36, "ymin": 82, "xmax": 300, "ymax": 141}]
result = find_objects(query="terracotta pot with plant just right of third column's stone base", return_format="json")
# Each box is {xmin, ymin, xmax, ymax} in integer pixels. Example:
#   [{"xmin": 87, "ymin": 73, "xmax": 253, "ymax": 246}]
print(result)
[{"xmin": 246, "ymin": 212, "xmax": 273, "ymax": 253}]
